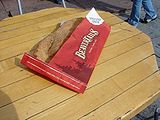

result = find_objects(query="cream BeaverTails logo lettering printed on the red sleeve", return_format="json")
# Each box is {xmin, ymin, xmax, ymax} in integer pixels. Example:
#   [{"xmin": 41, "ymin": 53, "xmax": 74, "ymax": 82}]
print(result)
[{"xmin": 75, "ymin": 28, "xmax": 99, "ymax": 59}]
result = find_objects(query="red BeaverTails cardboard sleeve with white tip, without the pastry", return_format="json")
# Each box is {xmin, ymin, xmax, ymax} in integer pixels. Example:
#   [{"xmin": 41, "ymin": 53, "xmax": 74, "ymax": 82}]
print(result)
[{"xmin": 21, "ymin": 8, "xmax": 110, "ymax": 93}]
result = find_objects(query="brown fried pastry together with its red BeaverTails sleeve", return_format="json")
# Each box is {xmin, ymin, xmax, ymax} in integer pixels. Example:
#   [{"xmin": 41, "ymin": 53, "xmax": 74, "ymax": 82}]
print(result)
[{"xmin": 21, "ymin": 8, "xmax": 111, "ymax": 93}]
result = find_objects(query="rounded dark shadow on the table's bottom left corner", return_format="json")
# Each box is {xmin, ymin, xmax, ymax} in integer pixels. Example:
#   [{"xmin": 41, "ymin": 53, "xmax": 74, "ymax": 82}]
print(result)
[{"xmin": 0, "ymin": 90, "xmax": 19, "ymax": 120}]
